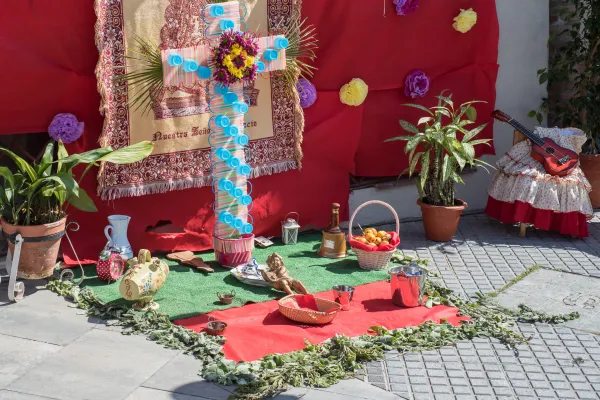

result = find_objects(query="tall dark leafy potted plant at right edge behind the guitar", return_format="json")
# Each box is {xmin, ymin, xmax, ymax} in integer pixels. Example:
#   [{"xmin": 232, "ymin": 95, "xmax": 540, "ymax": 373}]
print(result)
[{"xmin": 529, "ymin": 0, "xmax": 600, "ymax": 208}]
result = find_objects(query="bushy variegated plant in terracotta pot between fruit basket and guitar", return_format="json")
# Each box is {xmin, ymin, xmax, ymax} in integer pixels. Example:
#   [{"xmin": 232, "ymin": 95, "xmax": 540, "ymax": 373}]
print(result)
[{"xmin": 386, "ymin": 92, "xmax": 492, "ymax": 242}]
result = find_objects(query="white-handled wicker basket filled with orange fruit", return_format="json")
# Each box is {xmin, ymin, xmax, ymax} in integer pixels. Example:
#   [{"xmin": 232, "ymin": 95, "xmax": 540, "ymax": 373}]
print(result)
[{"xmin": 348, "ymin": 200, "xmax": 400, "ymax": 270}]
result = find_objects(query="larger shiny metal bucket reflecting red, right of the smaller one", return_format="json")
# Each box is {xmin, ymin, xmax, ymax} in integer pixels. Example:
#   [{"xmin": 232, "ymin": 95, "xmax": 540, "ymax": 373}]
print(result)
[{"xmin": 388, "ymin": 262, "xmax": 427, "ymax": 307}]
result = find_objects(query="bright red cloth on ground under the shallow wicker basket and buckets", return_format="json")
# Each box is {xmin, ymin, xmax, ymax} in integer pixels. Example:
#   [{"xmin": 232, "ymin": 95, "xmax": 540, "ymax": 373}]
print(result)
[{"xmin": 175, "ymin": 281, "xmax": 467, "ymax": 361}]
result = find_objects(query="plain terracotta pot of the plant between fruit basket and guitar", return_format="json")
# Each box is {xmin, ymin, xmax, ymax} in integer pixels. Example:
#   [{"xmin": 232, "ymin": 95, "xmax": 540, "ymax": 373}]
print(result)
[{"xmin": 417, "ymin": 199, "xmax": 467, "ymax": 242}]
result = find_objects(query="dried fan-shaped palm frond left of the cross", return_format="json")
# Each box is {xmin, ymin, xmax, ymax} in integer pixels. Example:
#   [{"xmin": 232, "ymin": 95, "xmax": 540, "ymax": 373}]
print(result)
[{"xmin": 115, "ymin": 36, "xmax": 163, "ymax": 114}]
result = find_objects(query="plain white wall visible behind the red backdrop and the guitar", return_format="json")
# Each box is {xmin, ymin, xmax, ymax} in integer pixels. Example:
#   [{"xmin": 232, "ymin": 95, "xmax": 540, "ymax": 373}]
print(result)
[{"xmin": 350, "ymin": 0, "xmax": 550, "ymax": 226}]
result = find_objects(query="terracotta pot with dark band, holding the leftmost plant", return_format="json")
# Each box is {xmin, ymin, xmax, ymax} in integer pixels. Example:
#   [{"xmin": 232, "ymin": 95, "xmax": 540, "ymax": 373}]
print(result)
[{"xmin": 1, "ymin": 218, "xmax": 67, "ymax": 279}]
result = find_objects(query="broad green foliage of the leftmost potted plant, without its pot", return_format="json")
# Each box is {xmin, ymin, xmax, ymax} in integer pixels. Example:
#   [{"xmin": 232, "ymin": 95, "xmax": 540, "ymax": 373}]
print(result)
[{"xmin": 0, "ymin": 141, "xmax": 154, "ymax": 225}]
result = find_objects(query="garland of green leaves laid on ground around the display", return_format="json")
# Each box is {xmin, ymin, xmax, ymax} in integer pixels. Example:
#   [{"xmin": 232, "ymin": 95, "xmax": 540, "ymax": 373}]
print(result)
[{"xmin": 47, "ymin": 255, "xmax": 579, "ymax": 400}]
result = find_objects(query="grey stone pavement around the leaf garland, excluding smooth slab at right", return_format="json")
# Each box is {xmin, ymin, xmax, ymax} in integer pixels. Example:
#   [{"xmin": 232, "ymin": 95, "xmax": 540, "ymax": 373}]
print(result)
[{"xmin": 0, "ymin": 215, "xmax": 600, "ymax": 400}]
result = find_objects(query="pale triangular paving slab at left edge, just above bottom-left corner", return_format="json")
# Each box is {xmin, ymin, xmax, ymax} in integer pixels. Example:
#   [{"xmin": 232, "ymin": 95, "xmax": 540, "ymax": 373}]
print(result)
[{"xmin": 0, "ymin": 335, "xmax": 61, "ymax": 390}]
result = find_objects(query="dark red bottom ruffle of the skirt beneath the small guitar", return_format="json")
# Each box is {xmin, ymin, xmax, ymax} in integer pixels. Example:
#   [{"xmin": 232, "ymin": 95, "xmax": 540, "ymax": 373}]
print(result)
[{"xmin": 485, "ymin": 196, "xmax": 590, "ymax": 238}]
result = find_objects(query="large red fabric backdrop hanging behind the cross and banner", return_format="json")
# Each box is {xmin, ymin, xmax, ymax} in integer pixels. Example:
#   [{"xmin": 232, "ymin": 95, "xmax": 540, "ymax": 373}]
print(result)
[{"xmin": 0, "ymin": 0, "xmax": 499, "ymax": 259}]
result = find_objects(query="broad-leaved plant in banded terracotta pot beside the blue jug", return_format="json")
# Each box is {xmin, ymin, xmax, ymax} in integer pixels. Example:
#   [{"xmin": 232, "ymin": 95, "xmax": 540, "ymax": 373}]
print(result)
[{"xmin": 0, "ymin": 141, "xmax": 154, "ymax": 279}]
